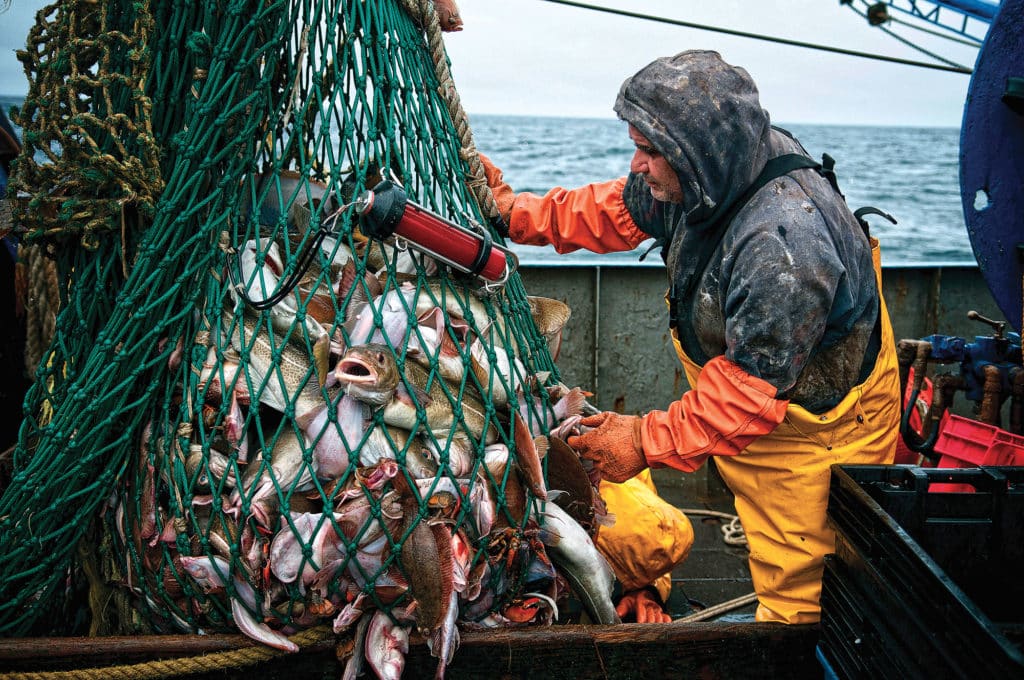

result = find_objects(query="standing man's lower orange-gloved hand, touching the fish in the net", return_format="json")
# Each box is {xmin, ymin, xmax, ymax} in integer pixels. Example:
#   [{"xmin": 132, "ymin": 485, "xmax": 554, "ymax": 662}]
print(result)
[{"xmin": 566, "ymin": 411, "xmax": 647, "ymax": 483}]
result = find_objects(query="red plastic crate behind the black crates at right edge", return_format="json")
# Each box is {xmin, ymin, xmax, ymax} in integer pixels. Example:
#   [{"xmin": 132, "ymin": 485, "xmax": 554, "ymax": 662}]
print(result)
[{"xmin": 931, "ymin": 414, "xmax": 1024, "ymax": 493}]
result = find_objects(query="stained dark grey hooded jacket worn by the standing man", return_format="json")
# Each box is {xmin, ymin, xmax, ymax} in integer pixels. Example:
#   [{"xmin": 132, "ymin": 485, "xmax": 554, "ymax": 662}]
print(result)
[{"xmin": 615, "ymin": 51, "xmax": 879, "ymax": 413}]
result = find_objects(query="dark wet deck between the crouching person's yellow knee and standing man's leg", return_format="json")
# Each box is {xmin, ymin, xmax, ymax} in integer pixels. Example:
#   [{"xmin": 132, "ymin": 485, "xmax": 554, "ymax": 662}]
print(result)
[{"xmin": 653, "ymin": 466, "xmax": 757, "ymax": 621}]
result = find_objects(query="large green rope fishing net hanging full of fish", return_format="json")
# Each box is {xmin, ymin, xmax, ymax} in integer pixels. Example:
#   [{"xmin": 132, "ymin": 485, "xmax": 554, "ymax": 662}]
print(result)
[{"xmin": 0, "ymin": 0, "xmax": 581, "ymax": 655}]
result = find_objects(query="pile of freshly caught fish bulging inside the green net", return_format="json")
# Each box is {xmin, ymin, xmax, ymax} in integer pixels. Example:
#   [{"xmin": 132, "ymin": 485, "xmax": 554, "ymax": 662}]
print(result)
[{"xmin": 111, "ymin": 176, "xmax": 617, "ymax": 678}]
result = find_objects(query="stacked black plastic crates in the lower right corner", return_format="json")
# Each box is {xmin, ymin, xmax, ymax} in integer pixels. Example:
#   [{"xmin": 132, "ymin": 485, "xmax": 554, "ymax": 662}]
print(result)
[{"xmin": 819, "ymin": 465, "xmax": 1024, "ymax": 678}]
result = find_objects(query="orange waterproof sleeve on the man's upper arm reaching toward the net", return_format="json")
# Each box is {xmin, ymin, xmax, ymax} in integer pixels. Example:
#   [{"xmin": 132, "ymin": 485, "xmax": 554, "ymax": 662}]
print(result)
[{"xmin": 509, "ymin": 177, "xmax": 648, "ymax": 253}]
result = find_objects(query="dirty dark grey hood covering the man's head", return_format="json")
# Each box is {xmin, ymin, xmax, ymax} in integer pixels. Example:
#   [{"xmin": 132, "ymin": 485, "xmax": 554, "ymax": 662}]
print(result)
[{"xmin": 615, "ymin": 50, "xmax": 771, "ymax": 227}]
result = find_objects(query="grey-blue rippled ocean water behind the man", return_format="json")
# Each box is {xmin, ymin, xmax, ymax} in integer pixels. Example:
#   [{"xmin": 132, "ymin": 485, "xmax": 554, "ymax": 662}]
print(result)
[{"xmin": 470, "ymin": 116, "xmax": 975, "ymax": 265}]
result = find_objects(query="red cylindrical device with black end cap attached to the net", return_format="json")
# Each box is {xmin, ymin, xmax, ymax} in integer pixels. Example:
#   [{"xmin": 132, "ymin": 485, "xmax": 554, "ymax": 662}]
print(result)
[{"xmin": 356, "ymin": 180, "xmax": 508, "ymax": 282}]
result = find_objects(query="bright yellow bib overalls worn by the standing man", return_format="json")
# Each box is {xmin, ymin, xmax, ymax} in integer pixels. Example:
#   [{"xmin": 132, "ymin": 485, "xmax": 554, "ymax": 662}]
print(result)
[{"xmin": 673, "ymin": 239, "xmax": 900, "ymax": 624}]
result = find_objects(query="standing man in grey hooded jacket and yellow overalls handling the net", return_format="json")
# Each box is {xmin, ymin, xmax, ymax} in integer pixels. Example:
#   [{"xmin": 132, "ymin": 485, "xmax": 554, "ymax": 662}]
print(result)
[{"xmin": 481, "ymin": 50, "xmax": 900, "ymax": 624}]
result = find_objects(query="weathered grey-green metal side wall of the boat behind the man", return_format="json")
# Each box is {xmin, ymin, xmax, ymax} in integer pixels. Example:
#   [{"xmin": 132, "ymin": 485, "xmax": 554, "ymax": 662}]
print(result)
[{"xmin": 519, "ymin": 265, "xmax": 1001, "ymax": 413}]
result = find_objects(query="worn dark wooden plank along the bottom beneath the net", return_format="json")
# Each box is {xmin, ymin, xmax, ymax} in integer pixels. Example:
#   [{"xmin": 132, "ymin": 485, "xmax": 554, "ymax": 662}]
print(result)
[{"xmin": 0, "ymin": 623, "xmax": 822, "ymax": 680}]
